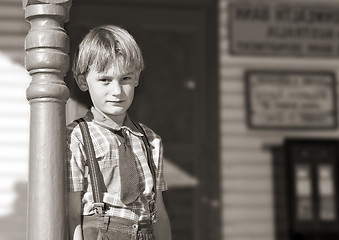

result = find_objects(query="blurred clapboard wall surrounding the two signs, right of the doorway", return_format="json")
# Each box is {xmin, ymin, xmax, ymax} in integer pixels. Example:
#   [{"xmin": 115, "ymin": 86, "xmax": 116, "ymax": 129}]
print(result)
[{"xmin": 219, "ymin": 0, "xmax": 339, "ymax": 240}]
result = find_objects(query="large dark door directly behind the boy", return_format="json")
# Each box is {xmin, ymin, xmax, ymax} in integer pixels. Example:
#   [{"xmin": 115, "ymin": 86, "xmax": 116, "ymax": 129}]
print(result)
[{"xmin": 66, "ymin": 1, "xmax": 219, "ymax": 240}]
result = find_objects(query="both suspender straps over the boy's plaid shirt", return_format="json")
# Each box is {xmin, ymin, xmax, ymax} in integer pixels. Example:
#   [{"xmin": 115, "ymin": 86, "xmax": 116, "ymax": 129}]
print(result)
[{"xmin": 76, "ymin": 118, "xmax": 157, "ymax": 222}]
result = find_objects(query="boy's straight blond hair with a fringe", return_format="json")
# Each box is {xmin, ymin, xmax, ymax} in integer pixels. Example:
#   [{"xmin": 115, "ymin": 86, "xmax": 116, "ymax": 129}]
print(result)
[{"xmin": 72, "ymin": 25, "xmax": 144, "ymax": 79}]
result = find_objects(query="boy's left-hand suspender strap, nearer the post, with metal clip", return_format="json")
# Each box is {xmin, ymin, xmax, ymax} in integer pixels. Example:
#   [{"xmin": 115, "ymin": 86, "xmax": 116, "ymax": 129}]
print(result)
[{"xmin": 76, "ymin": 118, "xmax": 104, "ymax": 215}]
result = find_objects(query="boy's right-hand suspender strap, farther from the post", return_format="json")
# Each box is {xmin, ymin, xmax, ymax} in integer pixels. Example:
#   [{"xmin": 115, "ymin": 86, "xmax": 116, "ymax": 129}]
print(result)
[{"xmin": 132, "ymin": 121, "xmax": 157, "ymax": 222}]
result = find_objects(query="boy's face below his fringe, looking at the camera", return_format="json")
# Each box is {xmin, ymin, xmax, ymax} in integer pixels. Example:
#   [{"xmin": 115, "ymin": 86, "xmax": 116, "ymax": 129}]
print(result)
[{"xmin": 78, "ymin": 64, "xmax": 139, "ymax": 124}]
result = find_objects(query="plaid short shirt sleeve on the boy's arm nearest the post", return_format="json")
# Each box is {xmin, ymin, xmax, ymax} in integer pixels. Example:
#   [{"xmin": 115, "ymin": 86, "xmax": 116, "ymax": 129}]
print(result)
[{"xmin": 67, "ymin": 124, "xmax": 86, "ymax": 192}]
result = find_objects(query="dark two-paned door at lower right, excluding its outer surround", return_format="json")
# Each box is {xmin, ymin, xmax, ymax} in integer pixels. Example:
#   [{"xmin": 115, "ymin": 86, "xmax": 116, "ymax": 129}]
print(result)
[{"xmin": 286, "ymin": 139, "xmax": 339, "ymax": 240}]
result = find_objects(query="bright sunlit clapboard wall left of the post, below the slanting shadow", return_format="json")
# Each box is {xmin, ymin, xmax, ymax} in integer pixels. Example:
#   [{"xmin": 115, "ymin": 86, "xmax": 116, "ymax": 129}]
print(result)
[{"xmin": 0, "ymin": 51, "xmax": 31, "ymax": 240}]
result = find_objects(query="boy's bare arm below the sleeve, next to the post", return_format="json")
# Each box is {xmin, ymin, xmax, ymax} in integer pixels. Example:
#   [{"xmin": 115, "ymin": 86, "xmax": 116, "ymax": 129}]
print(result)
[{"xmin": 68, "ymin": 192, "xmax": 83, "ymax": 240}]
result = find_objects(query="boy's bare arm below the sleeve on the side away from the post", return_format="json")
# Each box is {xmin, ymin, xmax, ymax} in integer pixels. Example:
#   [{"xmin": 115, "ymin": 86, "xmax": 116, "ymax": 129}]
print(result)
[{"xmin": 153, "ymin": 191, "xmax": 172, "ymax": 240}]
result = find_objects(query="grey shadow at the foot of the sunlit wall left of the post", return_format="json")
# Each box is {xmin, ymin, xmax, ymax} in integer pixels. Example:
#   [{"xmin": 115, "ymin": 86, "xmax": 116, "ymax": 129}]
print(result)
[{"xmin": 0, "ymin": 182, "xmax": 27, "ymax": 240}]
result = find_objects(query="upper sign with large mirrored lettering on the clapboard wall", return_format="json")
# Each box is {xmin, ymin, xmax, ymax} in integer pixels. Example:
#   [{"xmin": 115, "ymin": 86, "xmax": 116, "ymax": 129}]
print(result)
[{"xmin": 228, "ymin": 0, "xmax": 339, "ymax": 57}]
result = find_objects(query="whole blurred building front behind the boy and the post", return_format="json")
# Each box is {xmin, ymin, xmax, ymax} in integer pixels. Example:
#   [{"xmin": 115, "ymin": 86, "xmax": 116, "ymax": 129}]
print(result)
[{"xmin": 0, "ymin": 0, "xmax": 339, "ymax": 240}]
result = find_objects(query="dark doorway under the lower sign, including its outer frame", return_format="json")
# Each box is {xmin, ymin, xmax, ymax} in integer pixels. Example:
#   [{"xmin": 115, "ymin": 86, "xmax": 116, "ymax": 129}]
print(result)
[{"xmin": 272, "ymin": 138, "xmax": 339, "ymax": 240}]
